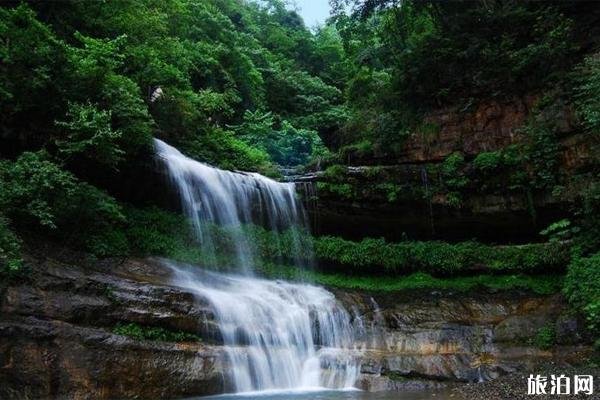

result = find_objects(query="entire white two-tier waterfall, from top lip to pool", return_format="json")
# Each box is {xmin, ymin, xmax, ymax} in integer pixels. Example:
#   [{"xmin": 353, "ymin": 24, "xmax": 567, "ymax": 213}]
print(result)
[{"xmin": 156, "ymin": 140, "xmax": 360, "ymax": 392}]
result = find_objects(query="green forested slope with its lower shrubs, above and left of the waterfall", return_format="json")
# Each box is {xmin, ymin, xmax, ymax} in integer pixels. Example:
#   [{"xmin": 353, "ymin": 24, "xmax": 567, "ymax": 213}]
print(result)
[{"xmin": 0, "ymin": 0, "xmax": 356, "ymax": 256}]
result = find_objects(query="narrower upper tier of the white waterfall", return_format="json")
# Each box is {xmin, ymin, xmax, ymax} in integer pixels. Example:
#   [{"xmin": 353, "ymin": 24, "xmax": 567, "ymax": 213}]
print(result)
[{"xmin": 155, "ymin": 139, "xmax": 307, "ymax": 271}]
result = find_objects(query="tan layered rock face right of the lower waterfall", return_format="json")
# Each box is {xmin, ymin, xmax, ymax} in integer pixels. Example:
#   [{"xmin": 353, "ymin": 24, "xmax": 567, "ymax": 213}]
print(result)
[{"xmin": 336, "ymin": 292, "xmax": 589, "ymax": 390}]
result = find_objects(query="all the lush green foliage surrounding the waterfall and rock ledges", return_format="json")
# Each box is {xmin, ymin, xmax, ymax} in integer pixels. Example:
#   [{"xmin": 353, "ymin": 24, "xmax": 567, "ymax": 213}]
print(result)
[{"xmin": 0, "ymin": 0, "xmax": 600, "ymax": 328}]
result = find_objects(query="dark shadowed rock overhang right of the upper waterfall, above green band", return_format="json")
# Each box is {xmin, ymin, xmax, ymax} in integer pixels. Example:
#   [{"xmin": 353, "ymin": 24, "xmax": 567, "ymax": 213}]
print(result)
[{"xmin": 297, "ymin": 165, "xmax": 568, "ymax": 243}]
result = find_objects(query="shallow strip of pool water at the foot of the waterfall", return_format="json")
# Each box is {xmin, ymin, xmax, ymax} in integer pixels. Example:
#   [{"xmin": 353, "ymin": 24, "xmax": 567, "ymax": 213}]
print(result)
[{"xmin": 188, "ymin": 389, "xmax": 459, "ymax": 400}]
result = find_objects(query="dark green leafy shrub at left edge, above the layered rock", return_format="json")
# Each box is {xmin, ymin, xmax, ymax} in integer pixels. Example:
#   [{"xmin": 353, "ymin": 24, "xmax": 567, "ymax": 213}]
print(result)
[{"xmin": 0, "ymin": 152, "xmax": 126, "ymax": 255}]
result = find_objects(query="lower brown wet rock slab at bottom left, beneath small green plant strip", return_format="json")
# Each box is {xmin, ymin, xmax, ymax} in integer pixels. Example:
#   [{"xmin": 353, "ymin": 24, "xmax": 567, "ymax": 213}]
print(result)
[{"xmin": 0, "ymin": 317, "xmax": 228, "ymax": 400}]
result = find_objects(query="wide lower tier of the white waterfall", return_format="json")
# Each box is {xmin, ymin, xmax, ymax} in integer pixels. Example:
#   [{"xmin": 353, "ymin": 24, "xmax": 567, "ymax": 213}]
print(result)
[{"xmin": 165, "ymin": 262, "xmax": 359, "ymax": 392}]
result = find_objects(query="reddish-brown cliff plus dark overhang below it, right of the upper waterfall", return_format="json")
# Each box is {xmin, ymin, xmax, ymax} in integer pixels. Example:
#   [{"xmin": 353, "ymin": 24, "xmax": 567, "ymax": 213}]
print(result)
[{"xmin": 297, "ymin": 96, "xmax": 598, "ymax": 243}]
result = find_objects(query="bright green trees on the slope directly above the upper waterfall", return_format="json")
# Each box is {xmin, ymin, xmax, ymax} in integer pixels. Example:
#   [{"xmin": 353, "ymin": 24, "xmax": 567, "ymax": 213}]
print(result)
[{"xmin": 0, "ymin": 0, "xmax": 344, "ymax": 170}]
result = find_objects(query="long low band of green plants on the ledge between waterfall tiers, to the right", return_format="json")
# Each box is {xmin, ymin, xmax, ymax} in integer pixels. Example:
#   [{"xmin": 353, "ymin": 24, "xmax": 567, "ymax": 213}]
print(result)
[{"xmin": 157, "ymin": 220, "xmax": 571, "ymax": 276}]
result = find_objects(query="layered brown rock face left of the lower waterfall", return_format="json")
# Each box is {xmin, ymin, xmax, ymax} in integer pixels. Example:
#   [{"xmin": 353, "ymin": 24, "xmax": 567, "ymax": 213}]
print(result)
[{"xmin": 0, "ymin": 250, "xmax": 229, "ymax": 399}]
